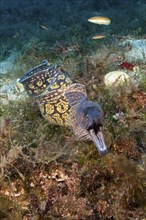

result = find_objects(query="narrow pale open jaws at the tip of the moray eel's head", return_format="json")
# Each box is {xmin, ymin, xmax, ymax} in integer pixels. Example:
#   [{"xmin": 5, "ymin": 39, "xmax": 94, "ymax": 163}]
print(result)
[{"xmin": 89, "ymin": 129, "xmax": 108, "ymax": 156}]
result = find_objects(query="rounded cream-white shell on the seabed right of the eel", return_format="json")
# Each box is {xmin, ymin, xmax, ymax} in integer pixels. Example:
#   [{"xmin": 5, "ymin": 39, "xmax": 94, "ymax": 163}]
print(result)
[{"xmin": 104, "ymin": 70, "xmax": 130, "ymax": 86}]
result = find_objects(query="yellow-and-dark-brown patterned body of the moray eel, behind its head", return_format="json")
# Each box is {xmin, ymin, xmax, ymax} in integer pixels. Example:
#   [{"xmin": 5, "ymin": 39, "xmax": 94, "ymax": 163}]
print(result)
[{"xmin": 20, "ymin": 60, "xmax": 85, "ymax": 126}]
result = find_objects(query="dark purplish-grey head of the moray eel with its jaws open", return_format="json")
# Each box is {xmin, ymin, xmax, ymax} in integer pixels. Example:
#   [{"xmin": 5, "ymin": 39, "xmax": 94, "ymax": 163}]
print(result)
[{"xmin": 74, "ymin": 99, "xmax": 108, "ymax": 155}]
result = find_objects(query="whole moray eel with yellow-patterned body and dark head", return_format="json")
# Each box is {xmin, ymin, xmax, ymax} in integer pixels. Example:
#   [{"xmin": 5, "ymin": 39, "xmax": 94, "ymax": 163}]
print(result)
[{"xmin": 19, "ymin": 60, "xmax": 108, "ymax": 155}]
